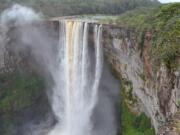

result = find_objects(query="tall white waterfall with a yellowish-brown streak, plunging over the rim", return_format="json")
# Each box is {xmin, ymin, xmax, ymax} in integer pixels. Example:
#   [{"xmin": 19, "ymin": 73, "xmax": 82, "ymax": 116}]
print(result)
[{"xmin": 49, "ymin": 20, "xmax": 103, "ymax": 135}]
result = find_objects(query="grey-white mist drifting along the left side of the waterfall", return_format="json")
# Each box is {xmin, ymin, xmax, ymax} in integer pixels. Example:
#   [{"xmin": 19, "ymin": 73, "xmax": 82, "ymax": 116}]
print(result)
[{"xmin": 0, "ymin": 4, "xmax": 57, "ymax": 135}]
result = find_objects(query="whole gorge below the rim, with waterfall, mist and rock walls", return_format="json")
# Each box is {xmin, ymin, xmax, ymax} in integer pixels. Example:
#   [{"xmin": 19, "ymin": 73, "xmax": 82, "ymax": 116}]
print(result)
[{"xmin": 0, "ymin": 3, "xmax": 180, "ymax": 135}]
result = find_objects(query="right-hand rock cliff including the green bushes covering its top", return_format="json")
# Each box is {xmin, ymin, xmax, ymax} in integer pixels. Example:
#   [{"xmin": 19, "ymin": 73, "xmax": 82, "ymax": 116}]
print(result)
[{"xmin": 101, "ymin": 4, "xmax": 180, "ymax": 135}]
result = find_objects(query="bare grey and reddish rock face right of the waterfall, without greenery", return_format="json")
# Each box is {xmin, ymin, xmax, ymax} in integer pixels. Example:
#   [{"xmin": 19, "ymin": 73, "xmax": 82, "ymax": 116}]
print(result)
[{"xmin": 103, "ymin": 26, "xmax": 180, "ymax": 135}]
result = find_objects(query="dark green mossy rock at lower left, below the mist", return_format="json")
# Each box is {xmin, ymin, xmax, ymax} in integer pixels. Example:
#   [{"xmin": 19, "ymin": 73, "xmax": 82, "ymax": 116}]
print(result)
[{"xmin": 0, "ymin": 71, "xmax": 51, "ymax": 135}]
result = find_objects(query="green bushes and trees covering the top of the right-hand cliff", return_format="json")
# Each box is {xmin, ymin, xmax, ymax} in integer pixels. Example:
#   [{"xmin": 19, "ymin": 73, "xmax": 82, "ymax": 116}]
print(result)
[{"xmin": 101, "ymin": 3, "xmax": 180, "ymax": 71}]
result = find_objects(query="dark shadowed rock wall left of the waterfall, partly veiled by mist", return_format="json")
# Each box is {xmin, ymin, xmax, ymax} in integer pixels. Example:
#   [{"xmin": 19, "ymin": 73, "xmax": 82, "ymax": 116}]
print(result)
[{"xmin": 0, "ymin": 21, "xmax": 56, "ymax": 135}]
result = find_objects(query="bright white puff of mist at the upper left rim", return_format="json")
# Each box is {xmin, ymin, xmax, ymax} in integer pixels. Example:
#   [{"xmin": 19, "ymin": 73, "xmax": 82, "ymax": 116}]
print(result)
[{"xmin": 0, "ymin": 4, "xmax": 40, "ymax": 71}]
